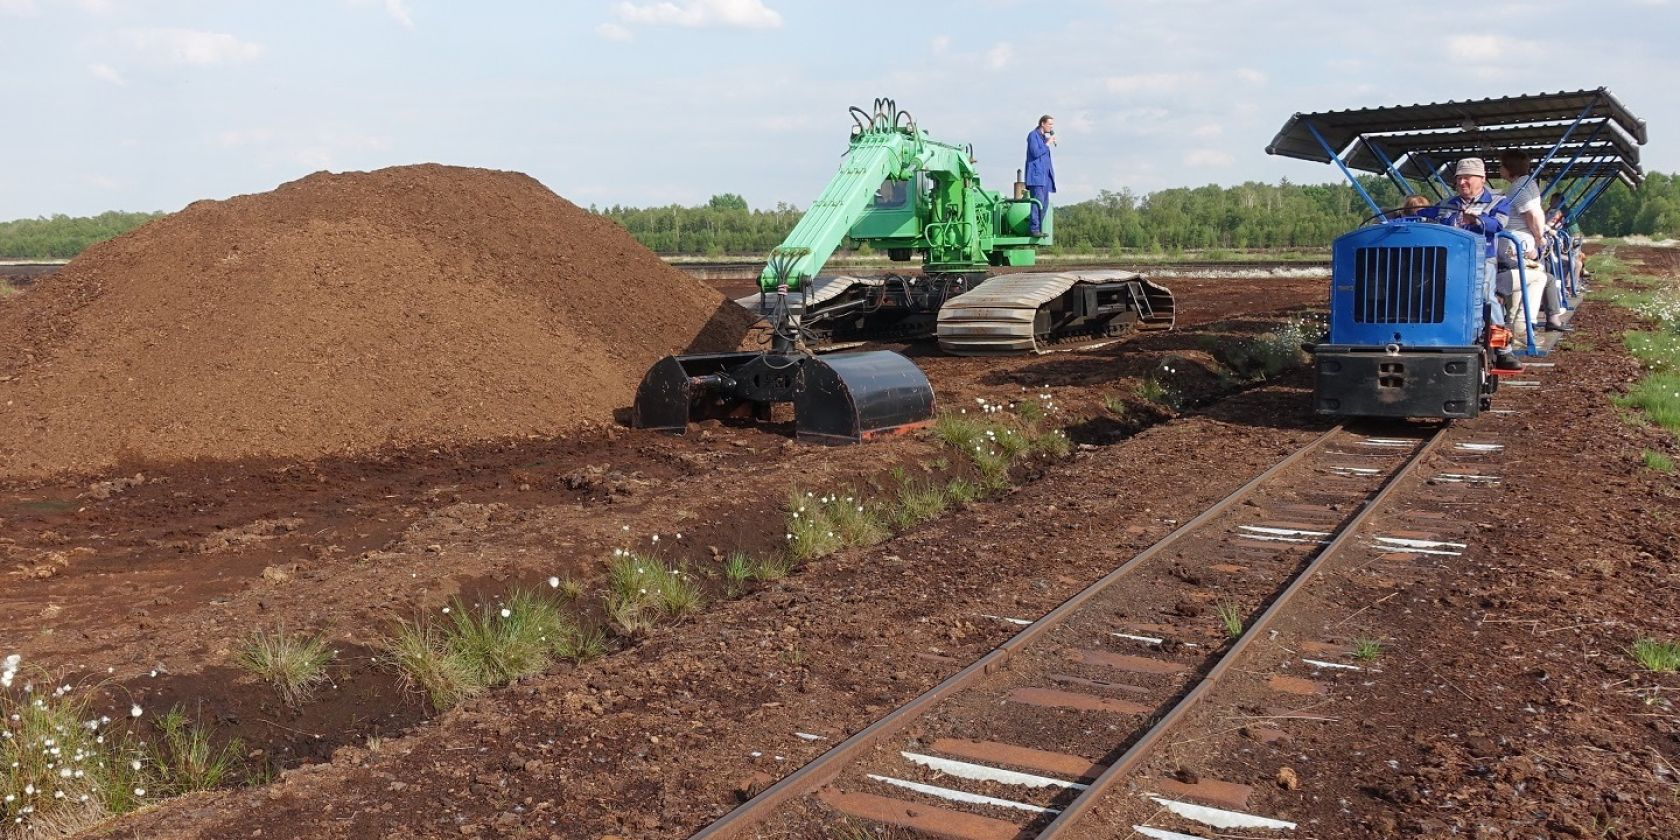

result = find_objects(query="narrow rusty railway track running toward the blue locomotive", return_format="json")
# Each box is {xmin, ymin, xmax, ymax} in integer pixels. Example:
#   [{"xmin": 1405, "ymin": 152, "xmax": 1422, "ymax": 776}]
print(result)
[{"xmin": 692, "ymin": 425, "xmax": 1446, "ymax": 840}]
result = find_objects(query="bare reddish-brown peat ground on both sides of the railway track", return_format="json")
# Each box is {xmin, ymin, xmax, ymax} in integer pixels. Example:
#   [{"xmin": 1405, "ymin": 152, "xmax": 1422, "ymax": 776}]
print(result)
[{"xmin": 0, "ymin": 252, "xmax": 1680, "ymax": 840}]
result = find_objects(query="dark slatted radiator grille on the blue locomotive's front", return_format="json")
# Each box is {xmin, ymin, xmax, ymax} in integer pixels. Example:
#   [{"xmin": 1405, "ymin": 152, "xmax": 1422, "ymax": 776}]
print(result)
[{"xmin": 1354, "ymin": 245, "xmax": 1446, "ymax": 324}]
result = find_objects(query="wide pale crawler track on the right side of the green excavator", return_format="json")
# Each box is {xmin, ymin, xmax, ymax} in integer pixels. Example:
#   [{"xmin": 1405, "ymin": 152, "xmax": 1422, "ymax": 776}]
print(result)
[{"xmin": 937, "ymin": 270, "xmax": 1174, "ymax": 356}]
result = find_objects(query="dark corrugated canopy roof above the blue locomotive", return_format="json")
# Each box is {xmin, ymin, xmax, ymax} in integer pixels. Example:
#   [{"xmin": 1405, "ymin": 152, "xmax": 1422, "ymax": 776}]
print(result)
[{"xmin": 1267, "ymin": 87, "xmax": 1646, "ymax": 163}]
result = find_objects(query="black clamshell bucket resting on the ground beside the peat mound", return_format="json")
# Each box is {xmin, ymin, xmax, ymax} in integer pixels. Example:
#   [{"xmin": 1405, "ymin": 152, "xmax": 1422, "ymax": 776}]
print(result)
[{"xmin": 630, "ymin": 349, "xmax": 934, "ymax": 444}]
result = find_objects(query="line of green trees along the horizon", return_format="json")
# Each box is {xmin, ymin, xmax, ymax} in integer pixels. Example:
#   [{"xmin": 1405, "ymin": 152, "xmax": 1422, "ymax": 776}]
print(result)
[{"xmin": 0, "ymin": 173, "xmax": 1680, "ymax": 259}]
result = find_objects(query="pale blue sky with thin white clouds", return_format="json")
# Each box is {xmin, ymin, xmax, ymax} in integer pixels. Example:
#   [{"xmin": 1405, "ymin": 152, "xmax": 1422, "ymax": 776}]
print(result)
[{"xmin": 0, "ymin": 0, "xmax": 1680, "ymax": 220}]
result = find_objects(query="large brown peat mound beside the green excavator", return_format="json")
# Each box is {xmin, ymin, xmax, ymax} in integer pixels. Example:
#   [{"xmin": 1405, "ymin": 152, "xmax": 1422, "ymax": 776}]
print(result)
[{"xmin": 0, "ymin": 165, "xmax": 748, "ymax": 479}]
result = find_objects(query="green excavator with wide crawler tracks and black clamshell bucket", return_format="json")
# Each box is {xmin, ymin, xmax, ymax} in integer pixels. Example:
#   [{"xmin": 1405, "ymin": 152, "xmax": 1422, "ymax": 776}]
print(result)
[{"xmin": 632, "ymin": 99, "xmax": 1173, "ymax": 444}]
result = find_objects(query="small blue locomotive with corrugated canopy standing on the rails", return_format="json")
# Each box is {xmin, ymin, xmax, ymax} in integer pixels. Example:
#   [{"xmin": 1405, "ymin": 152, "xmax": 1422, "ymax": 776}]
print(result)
[{"xmin": 1267, "ymin": 87, "xmax": 1646, "ymax": 418}]
